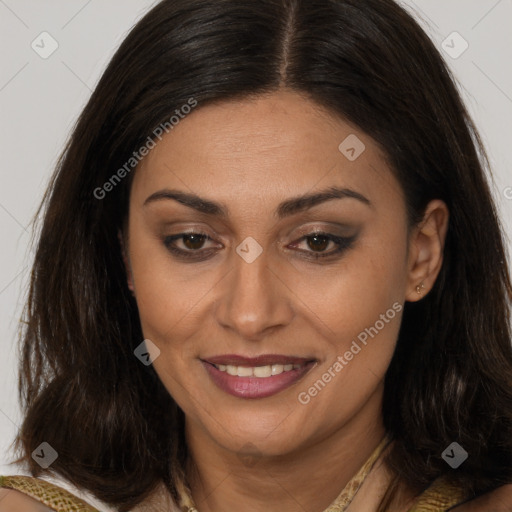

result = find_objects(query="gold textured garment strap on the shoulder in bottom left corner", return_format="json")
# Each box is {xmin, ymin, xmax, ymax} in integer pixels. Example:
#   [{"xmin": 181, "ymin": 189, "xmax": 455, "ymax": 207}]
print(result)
[{"xmin": 0, "ymin": 475, "xmax": 100, "ymax": 512}]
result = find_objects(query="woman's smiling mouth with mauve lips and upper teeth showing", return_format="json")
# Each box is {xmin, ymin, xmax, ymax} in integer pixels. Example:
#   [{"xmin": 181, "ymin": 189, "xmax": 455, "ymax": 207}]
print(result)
[{"xmin": 201, "ymin": 354, "xmax": 316, "ymax": 399}]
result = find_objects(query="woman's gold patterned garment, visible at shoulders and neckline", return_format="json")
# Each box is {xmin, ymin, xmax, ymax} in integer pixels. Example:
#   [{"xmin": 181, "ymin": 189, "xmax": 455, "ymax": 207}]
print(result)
[{"xmin": 0, "ymin": 437, "xmax": 467, "ymax": 512}]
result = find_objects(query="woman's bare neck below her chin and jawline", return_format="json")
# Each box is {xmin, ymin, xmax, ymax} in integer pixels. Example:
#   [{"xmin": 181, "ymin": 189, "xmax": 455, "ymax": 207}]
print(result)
[{"xmin": 186, "ymin": 386, "xmax": 385, "ymax": 512}]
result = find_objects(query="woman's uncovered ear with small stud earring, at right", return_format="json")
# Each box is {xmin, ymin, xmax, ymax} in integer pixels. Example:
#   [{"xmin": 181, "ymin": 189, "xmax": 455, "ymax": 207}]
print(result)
[{"xmin": 405, "ymin": 199, "xmax": 450, "ymax": 302}]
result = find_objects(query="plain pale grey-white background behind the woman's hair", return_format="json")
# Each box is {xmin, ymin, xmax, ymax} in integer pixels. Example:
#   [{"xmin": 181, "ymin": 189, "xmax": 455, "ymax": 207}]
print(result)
[{"xmin": 0, "ymin": 0, "xmax": 512, "ymax": 474}]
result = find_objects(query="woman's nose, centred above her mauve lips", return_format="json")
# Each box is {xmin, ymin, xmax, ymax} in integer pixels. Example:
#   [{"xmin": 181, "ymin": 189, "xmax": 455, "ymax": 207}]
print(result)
[{"xmin": 215, "ymin": 242, "xmax": 294, "ymax": 341}]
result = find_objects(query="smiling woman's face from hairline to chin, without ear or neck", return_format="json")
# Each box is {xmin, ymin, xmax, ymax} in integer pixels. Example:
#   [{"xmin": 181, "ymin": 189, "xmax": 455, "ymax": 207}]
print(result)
[{"xmin": 127, "ymin": 92, "xmax": 428, "ymax": 454}]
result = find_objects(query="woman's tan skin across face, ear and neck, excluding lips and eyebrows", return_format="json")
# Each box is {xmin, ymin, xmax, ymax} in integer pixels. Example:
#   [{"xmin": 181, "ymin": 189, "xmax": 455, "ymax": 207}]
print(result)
[{"xmin": 124, "ymin": 90, "xmax": 449, "ymax": 512}]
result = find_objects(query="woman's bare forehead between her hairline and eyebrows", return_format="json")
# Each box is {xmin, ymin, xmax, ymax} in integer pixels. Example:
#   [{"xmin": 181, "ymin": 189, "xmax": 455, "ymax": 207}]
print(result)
[{"xmin": 132, "ymin": 91, "xmax": 400, "ymax": 212}]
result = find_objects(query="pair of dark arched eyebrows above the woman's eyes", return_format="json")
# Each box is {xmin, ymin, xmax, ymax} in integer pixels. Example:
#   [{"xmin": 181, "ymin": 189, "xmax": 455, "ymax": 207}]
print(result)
[{"xmin": 144, "ymin": 187, "xmax": 372, "ymax": 219}]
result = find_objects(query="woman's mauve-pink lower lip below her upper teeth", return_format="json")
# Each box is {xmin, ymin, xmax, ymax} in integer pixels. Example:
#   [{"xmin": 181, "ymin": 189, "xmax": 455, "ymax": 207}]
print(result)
[{"xmin": 201, "ymin": 361, "xmax": 315, "ymax": 398}]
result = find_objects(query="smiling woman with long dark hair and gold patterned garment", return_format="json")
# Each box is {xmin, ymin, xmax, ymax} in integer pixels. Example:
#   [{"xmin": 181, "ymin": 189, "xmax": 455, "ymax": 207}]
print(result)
[{"xmin": 0, "ymin": 0, "xmax": 512, "ymax": 512}]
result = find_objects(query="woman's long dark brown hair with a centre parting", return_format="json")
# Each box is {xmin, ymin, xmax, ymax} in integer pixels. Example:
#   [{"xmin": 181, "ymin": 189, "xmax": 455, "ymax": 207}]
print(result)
[{"xmin": 8, "ymin": 0, "xmax": 512, "ymax": 512}]
